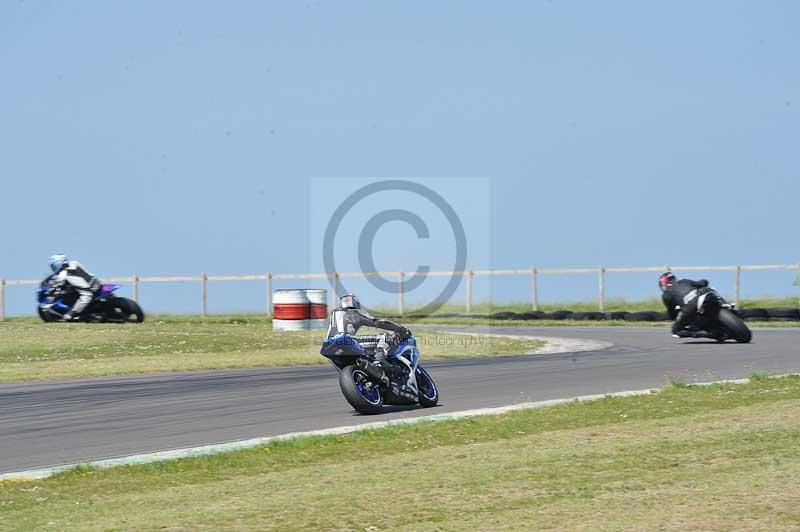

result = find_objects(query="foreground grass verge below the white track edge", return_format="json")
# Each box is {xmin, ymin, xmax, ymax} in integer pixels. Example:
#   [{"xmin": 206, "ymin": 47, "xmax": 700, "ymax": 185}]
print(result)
[{"xmin": 0, "ymin": 377, "xmax": 800, "ymax": 531}]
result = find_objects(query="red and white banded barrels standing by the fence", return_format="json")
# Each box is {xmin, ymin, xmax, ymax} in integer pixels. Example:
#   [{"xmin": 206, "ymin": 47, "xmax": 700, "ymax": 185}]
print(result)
[{"xmin": 272, "ymin": 288, "xmax": 328, "ymax": 331}]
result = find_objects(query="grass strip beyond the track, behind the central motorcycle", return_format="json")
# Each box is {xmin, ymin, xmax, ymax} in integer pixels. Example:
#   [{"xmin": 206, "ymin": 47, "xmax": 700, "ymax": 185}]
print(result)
[{"xmin": 0, "ymin": 315, "xmax": 544, "ymax": 382}]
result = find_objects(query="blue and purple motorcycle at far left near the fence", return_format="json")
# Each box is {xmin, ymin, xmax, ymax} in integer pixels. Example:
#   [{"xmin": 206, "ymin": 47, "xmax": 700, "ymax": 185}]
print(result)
[{"xmin": 36, "ymin": 278, "xmax": 144, "ymax": 323}]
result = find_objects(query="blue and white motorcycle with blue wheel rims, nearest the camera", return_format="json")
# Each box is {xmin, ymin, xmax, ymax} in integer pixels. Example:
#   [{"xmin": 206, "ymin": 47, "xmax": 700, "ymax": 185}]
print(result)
[{"xmin": 320, "ymin": 333, "xmax": 439, "ymax": 414}]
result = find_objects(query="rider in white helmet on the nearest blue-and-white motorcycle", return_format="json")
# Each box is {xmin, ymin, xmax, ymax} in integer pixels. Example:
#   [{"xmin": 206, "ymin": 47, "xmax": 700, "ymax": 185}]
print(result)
[{"xmin": 327, "ymin": 294, "xmax": 411, "ymax": 363}]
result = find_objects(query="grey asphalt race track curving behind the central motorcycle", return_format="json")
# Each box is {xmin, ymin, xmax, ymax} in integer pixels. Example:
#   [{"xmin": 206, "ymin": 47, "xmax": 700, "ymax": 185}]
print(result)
[{"xmin": 0, "ymin": 327, "xmax": 800, "ymax": 473}]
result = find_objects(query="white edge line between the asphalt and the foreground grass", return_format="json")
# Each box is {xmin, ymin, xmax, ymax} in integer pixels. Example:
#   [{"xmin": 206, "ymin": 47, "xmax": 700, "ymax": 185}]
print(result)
[{"xmin": 0, "ymin": 373, "xmax": 800, "ymax": 482}]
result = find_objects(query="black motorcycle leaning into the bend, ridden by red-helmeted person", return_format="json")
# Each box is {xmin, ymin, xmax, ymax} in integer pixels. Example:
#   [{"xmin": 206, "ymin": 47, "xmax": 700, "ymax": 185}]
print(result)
[{"xmin": 684, "ymin": 288, "xmax": 753, "ymax": 344}]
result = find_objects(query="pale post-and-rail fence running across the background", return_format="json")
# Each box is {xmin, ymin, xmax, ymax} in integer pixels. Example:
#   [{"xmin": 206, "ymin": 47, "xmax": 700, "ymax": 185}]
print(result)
[{"xmin": 0, "ymin": 263, "xmax": 800, "ymax": 321}]
